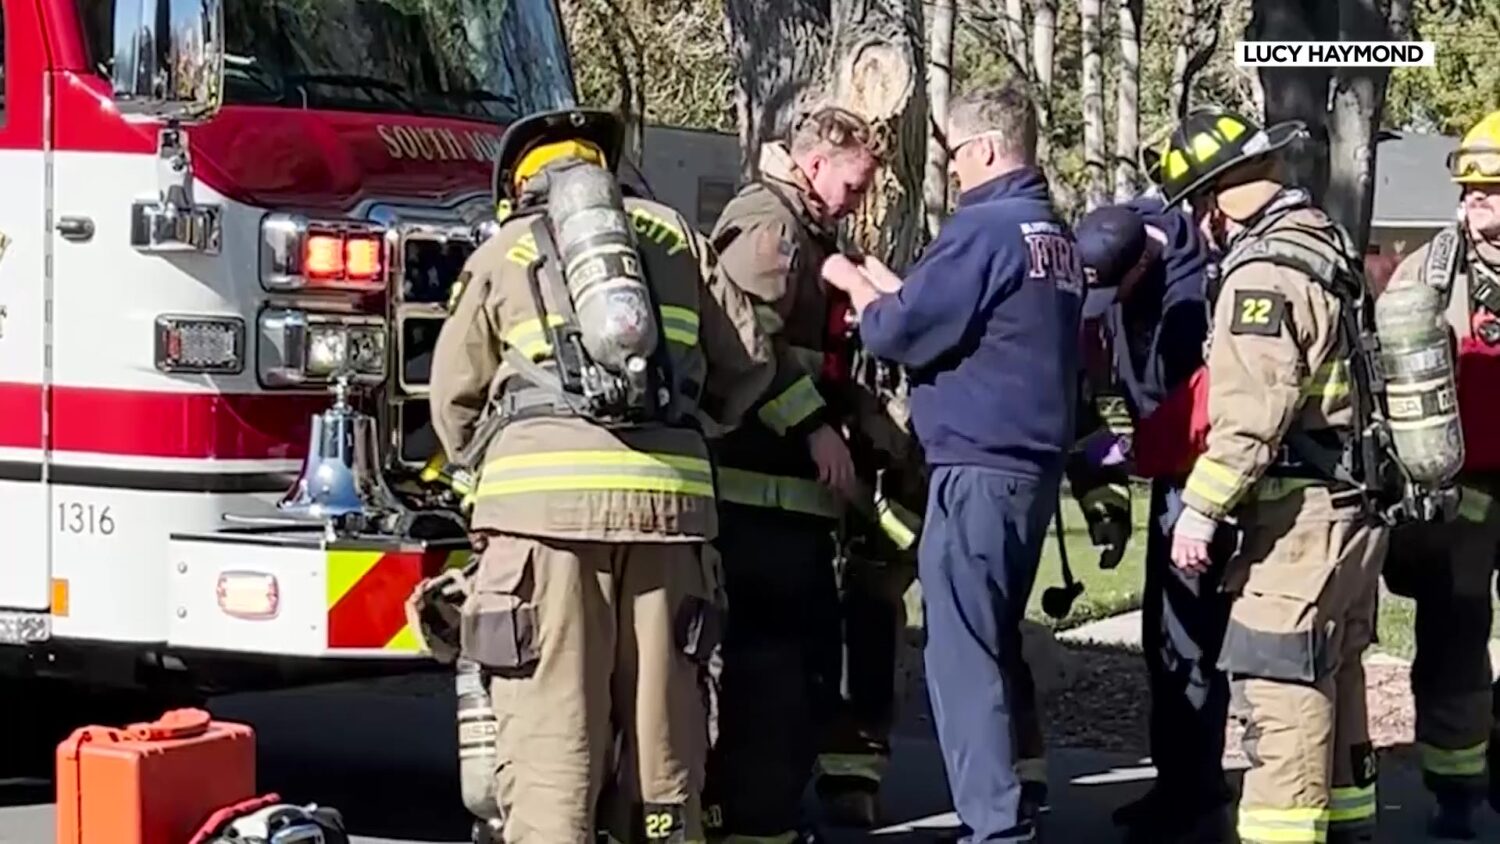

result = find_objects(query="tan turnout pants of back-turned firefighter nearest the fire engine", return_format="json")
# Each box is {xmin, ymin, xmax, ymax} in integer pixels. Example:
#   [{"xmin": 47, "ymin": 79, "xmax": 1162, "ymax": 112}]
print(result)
[{"xmin": 465, "ymin": 534, "xmax": 722, "ymax": 844}]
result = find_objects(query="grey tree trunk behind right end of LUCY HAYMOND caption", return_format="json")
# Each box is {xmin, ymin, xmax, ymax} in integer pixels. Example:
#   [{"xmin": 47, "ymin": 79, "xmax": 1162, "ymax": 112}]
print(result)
[{"xmin": 1323, "ymin": 0, "xmax": 1412, "ymax": 252}]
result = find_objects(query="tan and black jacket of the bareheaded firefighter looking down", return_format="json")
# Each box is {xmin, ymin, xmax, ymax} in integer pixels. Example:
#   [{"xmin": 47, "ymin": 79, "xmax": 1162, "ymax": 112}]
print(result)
[{"xmin": 713, "ymin": 144, "xmax": 837, "ymax": 516}]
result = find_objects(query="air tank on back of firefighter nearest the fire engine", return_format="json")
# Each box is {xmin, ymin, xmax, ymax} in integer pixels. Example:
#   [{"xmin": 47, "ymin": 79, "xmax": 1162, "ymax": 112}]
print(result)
[{"xmin": 548, "ymin": 163, "xmax": 660, "ymax": 408}]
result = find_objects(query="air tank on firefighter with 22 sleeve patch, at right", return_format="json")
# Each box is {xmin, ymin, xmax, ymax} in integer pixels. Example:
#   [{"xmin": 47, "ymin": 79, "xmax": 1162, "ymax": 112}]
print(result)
[{"xmin": 1376, "ymin": 282, "xmax": 1464, "ymax": 489}]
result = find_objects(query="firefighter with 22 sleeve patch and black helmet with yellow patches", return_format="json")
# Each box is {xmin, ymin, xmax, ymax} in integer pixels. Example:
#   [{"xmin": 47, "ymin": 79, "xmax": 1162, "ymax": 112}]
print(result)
[{"xmin": 1161, "ymin": 108, "xmax": 1388, "ymax": 844}]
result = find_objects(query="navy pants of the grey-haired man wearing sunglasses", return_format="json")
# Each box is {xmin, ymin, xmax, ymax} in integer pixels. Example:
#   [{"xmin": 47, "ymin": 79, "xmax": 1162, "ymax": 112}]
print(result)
[{"xmin": 918, "ymin": 466, "xmax": 1062, "ymax": 844}]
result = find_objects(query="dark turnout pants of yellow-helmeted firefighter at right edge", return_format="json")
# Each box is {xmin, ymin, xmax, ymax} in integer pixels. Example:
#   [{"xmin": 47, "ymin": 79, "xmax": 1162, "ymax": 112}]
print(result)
[{"xmin": 1386, "ymin": 478, "xmax": 1500, "ymax": 798}]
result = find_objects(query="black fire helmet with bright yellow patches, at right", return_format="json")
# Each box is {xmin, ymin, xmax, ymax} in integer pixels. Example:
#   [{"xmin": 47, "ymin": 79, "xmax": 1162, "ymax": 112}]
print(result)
[{"xmin": 1146, "ymin": 106, "xmax": 1307, "ymax": 205}]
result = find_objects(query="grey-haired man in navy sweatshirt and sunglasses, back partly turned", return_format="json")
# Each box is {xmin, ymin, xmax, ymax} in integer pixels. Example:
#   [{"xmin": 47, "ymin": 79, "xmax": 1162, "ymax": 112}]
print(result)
[{"xmin": 824, "ymin": 85, "xmax": 1083, "ymax": 843}]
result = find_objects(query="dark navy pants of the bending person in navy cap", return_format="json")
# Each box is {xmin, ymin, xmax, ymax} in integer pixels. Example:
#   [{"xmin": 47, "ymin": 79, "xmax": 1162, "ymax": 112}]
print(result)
[{"xmin": 1142, "ymin": 481, "xmax": 1235, "ymax": 811}]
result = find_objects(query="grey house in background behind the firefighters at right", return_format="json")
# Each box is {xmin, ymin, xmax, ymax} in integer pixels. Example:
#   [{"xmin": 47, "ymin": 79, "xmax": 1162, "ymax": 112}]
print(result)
[{"xmin": 1370, "ymin": 132, "xmax": 1458, "ymax": 258}]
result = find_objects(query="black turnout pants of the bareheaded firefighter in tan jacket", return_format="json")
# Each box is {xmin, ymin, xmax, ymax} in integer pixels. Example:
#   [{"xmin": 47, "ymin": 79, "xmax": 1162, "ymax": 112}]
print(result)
[{"xmin": 704, "ymin": 500, "xmax": 840, "ymax": 843}]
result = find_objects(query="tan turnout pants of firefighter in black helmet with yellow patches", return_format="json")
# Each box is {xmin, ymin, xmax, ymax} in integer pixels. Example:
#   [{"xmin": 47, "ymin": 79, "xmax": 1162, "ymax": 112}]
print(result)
[{"xmin": 1220, "ymin": 488, "xmax": 1388, "ymax": 844}]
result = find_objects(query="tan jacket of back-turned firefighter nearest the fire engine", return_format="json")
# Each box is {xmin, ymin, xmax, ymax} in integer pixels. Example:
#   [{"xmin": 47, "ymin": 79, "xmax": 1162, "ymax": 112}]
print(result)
[{"xmin": 431, "ymin": 198, "xmax": 774, "ymax": 543}]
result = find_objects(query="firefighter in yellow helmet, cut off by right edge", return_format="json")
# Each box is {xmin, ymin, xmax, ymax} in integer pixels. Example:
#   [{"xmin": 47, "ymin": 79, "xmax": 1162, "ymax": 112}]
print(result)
[{"xmin": 1386, "ymin": 111, "xmax": 1500, "ymax": 840}]
